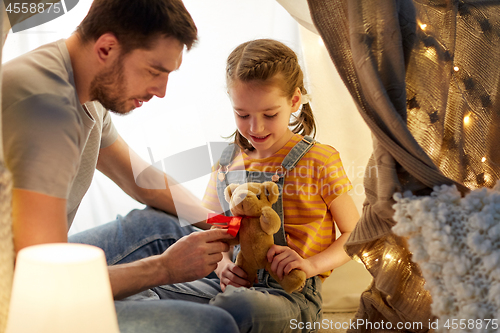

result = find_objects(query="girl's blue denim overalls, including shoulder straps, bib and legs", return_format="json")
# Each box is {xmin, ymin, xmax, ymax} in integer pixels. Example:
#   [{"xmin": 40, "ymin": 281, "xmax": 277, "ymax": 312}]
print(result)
[{"xmin": 153, "ymin": 137, "xmax": 322, "ymax": 333}]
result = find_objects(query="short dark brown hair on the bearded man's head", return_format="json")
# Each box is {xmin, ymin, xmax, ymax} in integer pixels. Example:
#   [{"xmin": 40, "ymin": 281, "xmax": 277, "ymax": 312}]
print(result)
[{"xmin": 76, "ymin": 0, "xmax": 198, "ymax": 54}]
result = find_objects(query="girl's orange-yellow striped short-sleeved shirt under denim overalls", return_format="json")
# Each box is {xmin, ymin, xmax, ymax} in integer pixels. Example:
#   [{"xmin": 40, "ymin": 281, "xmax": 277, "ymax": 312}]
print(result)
[{"xmin": 203, "ymin": 134, "xmax": 352, "ymax": 279}]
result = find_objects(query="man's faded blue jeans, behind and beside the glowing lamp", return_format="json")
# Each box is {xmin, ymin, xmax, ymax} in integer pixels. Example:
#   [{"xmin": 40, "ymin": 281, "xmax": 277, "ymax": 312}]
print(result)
[{"xmin": 69, "ymin": 207, "xmax": 238, "ymax": 333}]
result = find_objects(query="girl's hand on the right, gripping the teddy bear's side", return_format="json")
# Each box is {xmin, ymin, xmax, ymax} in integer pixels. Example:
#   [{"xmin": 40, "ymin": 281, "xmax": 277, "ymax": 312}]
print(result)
[{"xmin": 267, "ymin": 244, "xmax": 317, "ymax": 280}]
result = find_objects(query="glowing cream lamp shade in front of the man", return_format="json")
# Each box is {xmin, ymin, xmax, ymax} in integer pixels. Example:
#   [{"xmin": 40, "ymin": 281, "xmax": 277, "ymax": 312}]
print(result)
[{"xmin": 6, "ymin": 243, "xmax": 119, "ymax": 333}]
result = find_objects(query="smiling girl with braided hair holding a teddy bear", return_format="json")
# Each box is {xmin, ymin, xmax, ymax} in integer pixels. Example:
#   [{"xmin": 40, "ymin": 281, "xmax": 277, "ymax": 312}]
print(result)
[{"xmin": 154, "ymin": 39, "xmax": 358, "ymax": 332}]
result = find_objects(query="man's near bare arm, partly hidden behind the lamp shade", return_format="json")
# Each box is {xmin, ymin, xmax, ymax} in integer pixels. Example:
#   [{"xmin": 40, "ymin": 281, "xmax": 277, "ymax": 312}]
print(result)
[{"xmin": 12, "ymin": 189, "xmax": 232, "ymax": 299}]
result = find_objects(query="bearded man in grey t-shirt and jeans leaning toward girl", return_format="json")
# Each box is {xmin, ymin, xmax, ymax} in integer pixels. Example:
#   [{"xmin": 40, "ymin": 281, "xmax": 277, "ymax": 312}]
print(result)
[{"xmin": 2, "ymin": 0, "xmax": 236, "ymax": 332}]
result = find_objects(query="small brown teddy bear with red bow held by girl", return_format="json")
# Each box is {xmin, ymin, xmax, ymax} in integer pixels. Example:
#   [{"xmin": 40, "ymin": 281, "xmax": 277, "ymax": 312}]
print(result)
[{"xmin": 224, "ymin": 182, "xmax": 306, "ymax": 293}]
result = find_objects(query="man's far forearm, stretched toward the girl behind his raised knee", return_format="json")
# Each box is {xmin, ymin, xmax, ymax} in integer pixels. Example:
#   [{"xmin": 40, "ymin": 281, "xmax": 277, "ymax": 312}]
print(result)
[{"xmin": 97, "ymin": 136, "xmax": 210, "ymax": 229}]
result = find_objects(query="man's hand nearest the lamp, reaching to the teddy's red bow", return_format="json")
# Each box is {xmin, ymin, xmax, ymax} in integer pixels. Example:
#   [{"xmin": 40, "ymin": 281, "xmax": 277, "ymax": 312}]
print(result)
[{"xmin": 160, "ymin": 229, "xmax": 233, "ymax": 284}]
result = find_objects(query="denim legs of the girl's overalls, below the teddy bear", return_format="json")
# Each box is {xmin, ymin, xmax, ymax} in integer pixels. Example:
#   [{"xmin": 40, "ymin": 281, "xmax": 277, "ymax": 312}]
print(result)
[{"xmin": 153, "ymin": 274, "xmax": 322, "ymax": 333}]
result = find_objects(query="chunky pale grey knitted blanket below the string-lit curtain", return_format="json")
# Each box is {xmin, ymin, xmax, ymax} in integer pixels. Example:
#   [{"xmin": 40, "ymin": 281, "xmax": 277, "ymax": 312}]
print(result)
[{"xmin": 392, "ymin": 182, "xmax": 500, "ymax": 332}]
